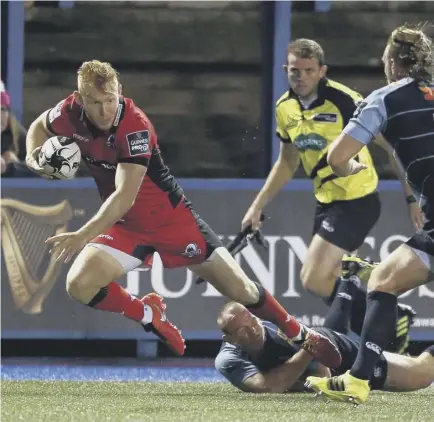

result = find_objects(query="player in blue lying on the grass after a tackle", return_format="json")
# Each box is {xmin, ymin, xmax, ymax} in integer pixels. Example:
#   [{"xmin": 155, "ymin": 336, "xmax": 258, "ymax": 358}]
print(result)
[{"xmin": 215, "ymin": 282, "xmax": 434, "ymax": 393}]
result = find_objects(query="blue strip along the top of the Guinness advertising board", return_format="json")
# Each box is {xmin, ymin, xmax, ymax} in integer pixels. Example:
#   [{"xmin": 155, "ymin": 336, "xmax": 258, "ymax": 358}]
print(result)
[{"xmin": 2, "ymin": 177, "xmax": 402, "ymax": 192}]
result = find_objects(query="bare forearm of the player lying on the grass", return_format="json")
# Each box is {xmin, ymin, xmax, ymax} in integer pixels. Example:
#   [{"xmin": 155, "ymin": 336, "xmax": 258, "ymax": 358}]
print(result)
[{"xmin": 243, "ymin": 350, "xmax": 330, "ymax": 393}]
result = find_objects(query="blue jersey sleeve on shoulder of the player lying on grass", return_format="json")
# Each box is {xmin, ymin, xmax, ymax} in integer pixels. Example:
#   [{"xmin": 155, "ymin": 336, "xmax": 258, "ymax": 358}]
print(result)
[{"xmin": 215, "ymin": 343, "xmax": 260, "ymax": 389}]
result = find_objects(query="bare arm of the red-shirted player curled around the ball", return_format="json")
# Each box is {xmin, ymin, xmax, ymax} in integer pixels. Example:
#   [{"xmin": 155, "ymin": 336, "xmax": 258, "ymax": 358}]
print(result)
[{"xmin": 26, "ymin": 110, "xmax": 54, "ymax": 175}]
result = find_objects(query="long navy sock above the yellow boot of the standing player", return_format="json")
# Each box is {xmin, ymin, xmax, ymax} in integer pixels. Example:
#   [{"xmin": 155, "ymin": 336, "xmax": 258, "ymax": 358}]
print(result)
[{"xmin": 350, "ymin": 291, "xmax": 398, "ymax": 380}]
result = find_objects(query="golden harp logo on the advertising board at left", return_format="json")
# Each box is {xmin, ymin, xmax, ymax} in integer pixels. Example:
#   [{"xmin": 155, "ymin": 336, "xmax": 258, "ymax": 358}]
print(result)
[{"xmin": 1, "ymin": 199, "xmax": 74, "ymax": 314}]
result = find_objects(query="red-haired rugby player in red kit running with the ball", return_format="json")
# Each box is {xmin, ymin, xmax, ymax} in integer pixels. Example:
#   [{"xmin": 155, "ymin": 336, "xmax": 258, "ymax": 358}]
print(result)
[{"xmin": 26, "ymin": 60, "xmax": 341, "ymax": 367}]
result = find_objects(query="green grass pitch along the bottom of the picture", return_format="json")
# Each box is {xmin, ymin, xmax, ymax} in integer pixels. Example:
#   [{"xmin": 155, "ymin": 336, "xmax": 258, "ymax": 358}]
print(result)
[{"xmin": 1, "ymin": 381, "xmax": 434, "ymax": 422}]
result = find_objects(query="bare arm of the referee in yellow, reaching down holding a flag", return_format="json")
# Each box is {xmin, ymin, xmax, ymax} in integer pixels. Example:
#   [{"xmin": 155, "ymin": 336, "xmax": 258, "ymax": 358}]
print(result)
[{"xmin": 242, "ymin": 142, "xmax": 300, "ymax": 229}]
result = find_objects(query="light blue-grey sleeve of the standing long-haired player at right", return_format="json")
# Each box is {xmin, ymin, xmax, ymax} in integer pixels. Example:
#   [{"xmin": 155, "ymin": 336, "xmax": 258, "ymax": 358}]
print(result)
[{"xmin": 343, "ymin": 89, "xmax": 387, "ymax": 145}]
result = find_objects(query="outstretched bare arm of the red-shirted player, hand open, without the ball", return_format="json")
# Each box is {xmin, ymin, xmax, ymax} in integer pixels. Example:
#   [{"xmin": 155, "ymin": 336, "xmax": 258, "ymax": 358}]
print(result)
[{"xmin": 47, "ymin": 163, "xmax": 147, "ymax": 262}]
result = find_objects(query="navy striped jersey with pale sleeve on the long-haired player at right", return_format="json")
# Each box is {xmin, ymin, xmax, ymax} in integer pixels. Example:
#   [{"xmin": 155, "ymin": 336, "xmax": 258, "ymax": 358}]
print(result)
[{"xmin": 344, "ymin": 78, "xmax": 434, "ymax": 233}]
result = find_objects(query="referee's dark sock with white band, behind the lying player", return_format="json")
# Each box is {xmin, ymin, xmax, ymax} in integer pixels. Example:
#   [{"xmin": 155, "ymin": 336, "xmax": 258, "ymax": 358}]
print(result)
[{"xmin": 324, "ymin": 276, "xmax": 360, "ymax": 334}]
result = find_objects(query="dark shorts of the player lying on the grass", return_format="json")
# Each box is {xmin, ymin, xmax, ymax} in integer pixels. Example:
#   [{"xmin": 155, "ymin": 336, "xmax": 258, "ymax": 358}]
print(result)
[{"xmin": 314, "ymin": 327, "xmax": 387, "ymax": 390}]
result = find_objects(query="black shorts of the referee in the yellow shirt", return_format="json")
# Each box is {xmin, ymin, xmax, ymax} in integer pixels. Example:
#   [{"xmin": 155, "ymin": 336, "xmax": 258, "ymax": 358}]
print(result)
[{"xmin": 313, "ymin": 192, "xmax": 381, "ymax": 252}]
